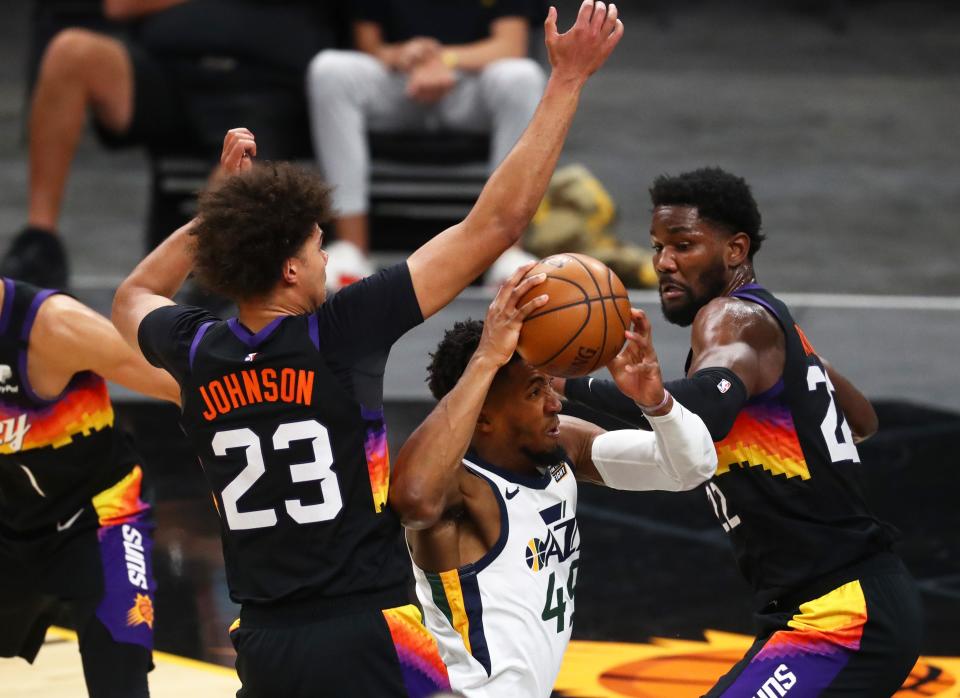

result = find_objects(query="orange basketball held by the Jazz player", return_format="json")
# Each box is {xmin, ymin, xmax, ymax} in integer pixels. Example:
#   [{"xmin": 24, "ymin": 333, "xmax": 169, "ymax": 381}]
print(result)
[{"xmin": 517, "ymin": 253, "xmax": 630, "ymax": 378}]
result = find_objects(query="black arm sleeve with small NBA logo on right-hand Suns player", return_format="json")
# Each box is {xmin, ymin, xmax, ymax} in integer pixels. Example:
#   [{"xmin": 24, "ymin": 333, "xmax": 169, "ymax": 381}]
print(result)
[{"xmin": 566, "ymin": 367, "xmax": 748, "ymax": 441}]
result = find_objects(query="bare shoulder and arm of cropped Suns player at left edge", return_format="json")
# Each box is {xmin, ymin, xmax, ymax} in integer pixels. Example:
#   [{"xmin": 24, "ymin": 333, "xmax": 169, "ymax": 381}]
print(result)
[{"xmin": 29, "ymin": 295, "xmax": 180, "ymax": 403}]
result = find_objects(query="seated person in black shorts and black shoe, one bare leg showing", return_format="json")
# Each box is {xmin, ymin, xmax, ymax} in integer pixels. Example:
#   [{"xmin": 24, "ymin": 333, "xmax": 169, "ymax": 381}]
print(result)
[{"xmin": 0, "ymin": 0, "xmax": 330, "ymax": 288}]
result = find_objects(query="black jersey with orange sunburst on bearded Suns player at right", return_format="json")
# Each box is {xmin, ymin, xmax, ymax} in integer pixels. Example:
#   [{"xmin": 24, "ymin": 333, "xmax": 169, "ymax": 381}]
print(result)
[{"xmin": 688, "ymin": 284, "xmax": 891, "ymax": 605}]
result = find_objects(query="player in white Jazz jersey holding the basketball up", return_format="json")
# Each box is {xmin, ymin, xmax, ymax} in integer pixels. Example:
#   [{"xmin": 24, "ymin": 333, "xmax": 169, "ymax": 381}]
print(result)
[{"xmin": 390, "ymin": 265, "xmax": 717, "ymax": 698}]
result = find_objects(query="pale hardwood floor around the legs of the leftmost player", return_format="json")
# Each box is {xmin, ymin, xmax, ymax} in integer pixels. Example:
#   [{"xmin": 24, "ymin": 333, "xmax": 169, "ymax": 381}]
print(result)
[{"xmin": 0, "ymin": 628, "xmax": 240, "ymax": 698}]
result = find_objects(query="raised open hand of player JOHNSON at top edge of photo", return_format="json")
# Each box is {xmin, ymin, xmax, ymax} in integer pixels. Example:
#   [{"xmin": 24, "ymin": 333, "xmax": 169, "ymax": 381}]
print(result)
[{"xmin": 544, "ymin": 0, "xmax": 623, "ymax": 80}]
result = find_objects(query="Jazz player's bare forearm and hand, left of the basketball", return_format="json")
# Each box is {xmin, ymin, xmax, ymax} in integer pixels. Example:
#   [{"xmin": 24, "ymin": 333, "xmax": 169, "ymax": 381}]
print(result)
[{"xmin": 390, "ymin": 264, "xmax": 546, "ymax": 530}]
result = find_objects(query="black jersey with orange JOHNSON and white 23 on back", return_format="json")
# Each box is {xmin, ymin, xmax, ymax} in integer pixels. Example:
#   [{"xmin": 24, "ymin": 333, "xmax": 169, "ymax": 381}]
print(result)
[{"xmin": 139, "ymin": 263, "xmax": 423, "ymax": 604}]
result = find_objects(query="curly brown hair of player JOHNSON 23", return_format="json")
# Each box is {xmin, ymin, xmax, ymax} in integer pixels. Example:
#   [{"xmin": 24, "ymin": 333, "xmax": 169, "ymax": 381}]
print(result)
[{"xmin": 193, "ymin": 162, "xmax": 331, "ymax": 300}]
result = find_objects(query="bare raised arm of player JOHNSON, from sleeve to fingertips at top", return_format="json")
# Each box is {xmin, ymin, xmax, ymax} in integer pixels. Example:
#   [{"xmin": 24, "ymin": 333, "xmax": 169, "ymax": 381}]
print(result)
[{"xmin": 407, "ymin": 0, "xmax": 623, "ymax": 318}]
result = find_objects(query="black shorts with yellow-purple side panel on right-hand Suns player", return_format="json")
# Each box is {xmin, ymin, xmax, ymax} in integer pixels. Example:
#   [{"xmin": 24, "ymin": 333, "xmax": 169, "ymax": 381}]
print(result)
[{"xmin": 707, "ymin": 560, "xmax": 922, "ymax": 698}]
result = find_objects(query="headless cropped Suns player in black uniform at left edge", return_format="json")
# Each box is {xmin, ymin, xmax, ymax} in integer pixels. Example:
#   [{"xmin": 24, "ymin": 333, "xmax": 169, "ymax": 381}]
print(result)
[{"xmin": 0, "ymin": 279, "xmax": 179, "ymax": 698}]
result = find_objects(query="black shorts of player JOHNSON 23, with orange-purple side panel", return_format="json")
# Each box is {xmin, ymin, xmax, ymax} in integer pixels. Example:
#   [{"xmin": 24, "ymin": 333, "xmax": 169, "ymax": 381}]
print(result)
[{"xmin": 230, "ymin": 606, "xmax": 450, "ymax": 698}]
